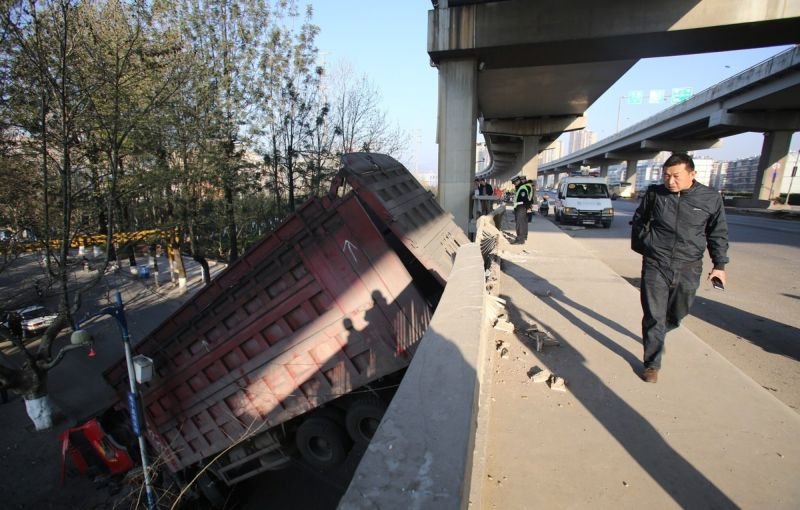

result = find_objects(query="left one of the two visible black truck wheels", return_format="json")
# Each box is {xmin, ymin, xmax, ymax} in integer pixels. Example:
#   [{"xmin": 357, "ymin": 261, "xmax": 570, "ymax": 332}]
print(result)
[{"xmin": 295, "ymin": 418, "xmax": 349, "ymax": 471}]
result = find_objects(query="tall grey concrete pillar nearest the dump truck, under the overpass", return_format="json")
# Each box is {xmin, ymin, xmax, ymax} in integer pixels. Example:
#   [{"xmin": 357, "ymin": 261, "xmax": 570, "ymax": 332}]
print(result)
[{"xmin": 436, "ymin": 59, "xmax": 478, "ymax": 232}]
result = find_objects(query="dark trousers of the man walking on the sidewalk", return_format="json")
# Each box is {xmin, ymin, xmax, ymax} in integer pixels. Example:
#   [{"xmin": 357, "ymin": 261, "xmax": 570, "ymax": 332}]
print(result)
[{"xmin": 641, "ymin": 257, "xmax": 703, "ymax": 368}]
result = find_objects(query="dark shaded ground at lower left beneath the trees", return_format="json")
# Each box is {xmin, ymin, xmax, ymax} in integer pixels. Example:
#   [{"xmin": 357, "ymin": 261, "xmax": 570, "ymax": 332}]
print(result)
[{"xmin": 0, "ymin": 255, "xmax": 222, "ymax": 510}]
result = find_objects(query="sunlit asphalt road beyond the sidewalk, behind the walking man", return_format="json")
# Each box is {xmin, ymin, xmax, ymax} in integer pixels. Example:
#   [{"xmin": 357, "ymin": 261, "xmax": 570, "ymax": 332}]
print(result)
[{"xmin": 537, "ymin": 200, "xmax": 800, "ymax": 412}]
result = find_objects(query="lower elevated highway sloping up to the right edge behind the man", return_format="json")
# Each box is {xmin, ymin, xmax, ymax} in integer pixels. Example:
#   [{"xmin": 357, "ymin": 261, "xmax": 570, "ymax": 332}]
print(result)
[{"xmin": 538, "ymin": 46, "xmax": 800, "ymax": 200}]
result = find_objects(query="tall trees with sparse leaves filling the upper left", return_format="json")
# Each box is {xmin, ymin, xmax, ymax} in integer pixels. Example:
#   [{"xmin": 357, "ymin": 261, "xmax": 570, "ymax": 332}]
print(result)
[{"xmin": 0, "ymin": 0, "xmax": 405, "ymax": 258}]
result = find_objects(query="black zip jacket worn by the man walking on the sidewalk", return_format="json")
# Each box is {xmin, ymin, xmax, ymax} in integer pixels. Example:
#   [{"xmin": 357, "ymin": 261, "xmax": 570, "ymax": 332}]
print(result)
[{"xmin": 632, "ymin": 181, "xmax": 728, "ymax": 269}]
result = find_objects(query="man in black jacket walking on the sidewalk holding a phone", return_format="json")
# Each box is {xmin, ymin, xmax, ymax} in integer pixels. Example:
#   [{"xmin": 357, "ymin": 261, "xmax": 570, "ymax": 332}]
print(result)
[{"xmin": 632, "ymin": 154, "xmax": 728, "ymax": 383}]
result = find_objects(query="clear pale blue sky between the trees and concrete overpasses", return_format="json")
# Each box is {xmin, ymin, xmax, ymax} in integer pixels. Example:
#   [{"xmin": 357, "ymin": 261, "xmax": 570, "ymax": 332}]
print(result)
[{"xmin": 313, "ymin": 0, "xmax": 800, "ymax": 172}]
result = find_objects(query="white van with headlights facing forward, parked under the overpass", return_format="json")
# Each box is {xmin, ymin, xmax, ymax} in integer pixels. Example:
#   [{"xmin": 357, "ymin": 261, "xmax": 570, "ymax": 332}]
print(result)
[{"xmin": 554, "ymin": 176, "xmax": 614, "ymax": 228}]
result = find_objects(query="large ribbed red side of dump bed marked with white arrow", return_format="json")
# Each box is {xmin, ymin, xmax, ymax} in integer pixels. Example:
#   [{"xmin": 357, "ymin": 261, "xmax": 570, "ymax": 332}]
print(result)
[{"xmin": 106, "ymin": 194, "xmax": 431, "ymax": 469}]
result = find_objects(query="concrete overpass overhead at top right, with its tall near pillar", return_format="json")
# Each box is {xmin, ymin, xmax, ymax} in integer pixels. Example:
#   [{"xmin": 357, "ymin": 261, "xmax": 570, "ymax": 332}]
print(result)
[{"xmin": 428, "ymin": 0, "xmax": 800, "ymax": 227}]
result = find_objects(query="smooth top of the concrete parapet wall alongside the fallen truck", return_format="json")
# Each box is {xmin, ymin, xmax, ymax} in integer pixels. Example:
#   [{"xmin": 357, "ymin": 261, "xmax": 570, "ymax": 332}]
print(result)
[{"xmin": 339, "ymin": 243, "xmax": 486, "ymax": 510}]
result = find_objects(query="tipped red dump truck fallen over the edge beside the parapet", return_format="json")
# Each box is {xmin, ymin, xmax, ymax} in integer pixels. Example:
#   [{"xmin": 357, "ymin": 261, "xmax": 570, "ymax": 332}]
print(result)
[{"xmin": 62, "ymin": 153, "xmax": 469, "ymax": 504}]
